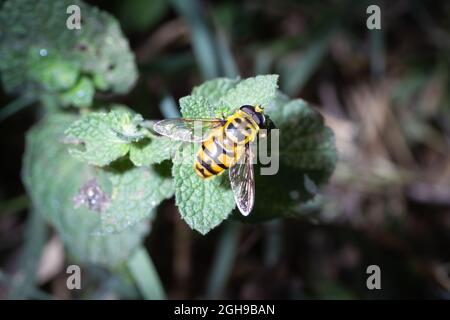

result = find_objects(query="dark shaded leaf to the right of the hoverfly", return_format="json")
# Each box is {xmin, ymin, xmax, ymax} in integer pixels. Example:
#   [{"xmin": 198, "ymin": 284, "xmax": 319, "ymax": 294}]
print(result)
[{"xmin": 239, "ymin": 93, "xmax": 337, "ymax": 222}]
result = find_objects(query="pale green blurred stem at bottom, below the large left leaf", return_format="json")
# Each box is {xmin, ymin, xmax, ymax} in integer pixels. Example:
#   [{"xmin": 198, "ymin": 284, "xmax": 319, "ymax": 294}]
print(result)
[{"xmin": 128, "ymin": 247, "xmax": 166, "ymax": 300}]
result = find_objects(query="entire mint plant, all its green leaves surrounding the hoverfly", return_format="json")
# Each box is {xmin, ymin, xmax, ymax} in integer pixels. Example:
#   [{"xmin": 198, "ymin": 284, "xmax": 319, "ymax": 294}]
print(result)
[{"xmin": 0, "ymin": 0, "xmax": 336, "ymax": 298}]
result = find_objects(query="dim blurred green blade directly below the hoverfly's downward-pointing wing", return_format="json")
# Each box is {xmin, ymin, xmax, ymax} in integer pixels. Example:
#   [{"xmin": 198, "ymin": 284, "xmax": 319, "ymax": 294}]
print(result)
[{"xmin": 206, "ymin": 223, "xmax": 240, "ymax": 299}]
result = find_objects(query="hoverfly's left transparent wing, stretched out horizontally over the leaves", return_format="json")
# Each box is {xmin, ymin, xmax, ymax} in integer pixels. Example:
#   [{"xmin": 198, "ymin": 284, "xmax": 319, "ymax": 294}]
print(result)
[{"xmin": 153, "ymin": 118, "xmax": 223, "ymax": 142}]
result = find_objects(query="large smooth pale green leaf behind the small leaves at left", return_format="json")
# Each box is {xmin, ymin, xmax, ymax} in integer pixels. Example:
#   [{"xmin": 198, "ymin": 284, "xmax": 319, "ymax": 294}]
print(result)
[{"xmin": 22, "ymin": 114, "xmax": 151, "ymax": 267}]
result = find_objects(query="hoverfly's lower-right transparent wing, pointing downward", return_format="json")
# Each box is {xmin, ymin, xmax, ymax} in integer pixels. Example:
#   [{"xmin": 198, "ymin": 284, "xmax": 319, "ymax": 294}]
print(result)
[{"xmin": 230, "ymin": 144, "xmax": 255, "ymax": 216}]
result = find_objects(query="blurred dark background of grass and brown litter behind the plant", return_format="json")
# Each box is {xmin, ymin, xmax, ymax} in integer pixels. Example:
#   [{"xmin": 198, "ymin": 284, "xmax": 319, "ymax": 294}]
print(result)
[{"xmin": 0, "ymin": 0, "xmax": 450, "ymax": 299}]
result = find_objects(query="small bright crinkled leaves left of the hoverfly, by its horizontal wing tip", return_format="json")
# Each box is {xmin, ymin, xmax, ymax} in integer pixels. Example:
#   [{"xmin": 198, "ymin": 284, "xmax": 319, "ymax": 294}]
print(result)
[{"xmin": 65, "ymin": 105, "xmax": 181, "ymax": 167}]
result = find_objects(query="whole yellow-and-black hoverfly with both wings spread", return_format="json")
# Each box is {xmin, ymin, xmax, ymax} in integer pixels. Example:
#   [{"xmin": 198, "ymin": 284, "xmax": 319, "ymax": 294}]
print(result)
[{"xmin": 153, "ymin": 105, "xmax": 266, "ymax": 216}]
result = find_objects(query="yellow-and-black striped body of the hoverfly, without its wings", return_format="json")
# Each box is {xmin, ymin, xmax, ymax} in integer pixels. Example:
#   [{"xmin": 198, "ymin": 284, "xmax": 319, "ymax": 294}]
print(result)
[{"xmin": 194, "ymin": 111, "xmax": 259, "ymax": 179}]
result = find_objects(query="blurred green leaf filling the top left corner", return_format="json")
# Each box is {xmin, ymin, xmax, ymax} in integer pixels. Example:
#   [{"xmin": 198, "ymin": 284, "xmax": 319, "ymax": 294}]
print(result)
[{"xmin": 0, "ymin": 0, "xmax": 137, "ymax": 105}]
